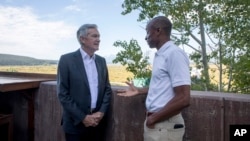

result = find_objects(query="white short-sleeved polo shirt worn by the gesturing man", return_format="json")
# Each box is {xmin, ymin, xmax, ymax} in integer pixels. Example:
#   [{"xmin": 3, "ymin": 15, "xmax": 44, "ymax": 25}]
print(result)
[{"xmin": 146, "ymin": 41, "xmax": 191, "ymax": 112}]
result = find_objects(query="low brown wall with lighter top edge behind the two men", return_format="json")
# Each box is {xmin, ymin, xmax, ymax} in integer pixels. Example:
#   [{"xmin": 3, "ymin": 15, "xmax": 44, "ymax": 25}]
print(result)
[{"xmin": 35, "ymin": 82, "xmax": 250, "ymax": 141}]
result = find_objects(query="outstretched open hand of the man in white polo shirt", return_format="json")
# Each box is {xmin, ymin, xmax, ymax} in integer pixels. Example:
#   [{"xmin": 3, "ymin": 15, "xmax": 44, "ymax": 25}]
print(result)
[{"xmin": 116, "ymin": 82, "xmax": 139, "ymax": 97}]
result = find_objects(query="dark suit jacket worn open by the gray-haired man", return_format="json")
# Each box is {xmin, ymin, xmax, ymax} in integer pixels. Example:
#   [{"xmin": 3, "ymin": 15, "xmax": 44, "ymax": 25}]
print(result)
[{"xmin": 57, "ymin": 50, "xmax": 112, "ymax": 134}]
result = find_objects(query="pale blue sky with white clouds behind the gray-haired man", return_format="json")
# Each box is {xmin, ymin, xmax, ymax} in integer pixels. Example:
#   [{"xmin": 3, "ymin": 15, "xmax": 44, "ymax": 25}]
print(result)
[{"xmin": 0, "ymin": 0, "xmax": 155, "ymax": 60}]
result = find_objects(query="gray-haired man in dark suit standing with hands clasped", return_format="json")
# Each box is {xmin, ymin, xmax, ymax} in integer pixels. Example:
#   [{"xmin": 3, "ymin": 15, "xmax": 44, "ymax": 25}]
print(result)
[{"xmin": 57, "ymin": 24, "xmax": 112, "ymax": 141}]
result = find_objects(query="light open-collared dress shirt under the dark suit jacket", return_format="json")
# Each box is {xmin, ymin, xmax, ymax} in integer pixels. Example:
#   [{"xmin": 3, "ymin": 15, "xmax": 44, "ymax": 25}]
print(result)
[{"xmin": 80, "ymin": 48, "xmax": 98, "ymax": 109}]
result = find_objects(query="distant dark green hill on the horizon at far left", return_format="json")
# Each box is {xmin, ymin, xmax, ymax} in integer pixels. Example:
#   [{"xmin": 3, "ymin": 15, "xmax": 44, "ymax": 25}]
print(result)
[{"xmin": 0, "ymin": 54, "xmax": 58, "ymax": 66}]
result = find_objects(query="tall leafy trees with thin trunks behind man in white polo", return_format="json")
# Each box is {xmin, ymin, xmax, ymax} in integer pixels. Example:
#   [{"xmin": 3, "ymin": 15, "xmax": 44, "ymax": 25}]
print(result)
[{"xmin": 122, "ymin": 0, "xmax": 250, "ymax": 91}]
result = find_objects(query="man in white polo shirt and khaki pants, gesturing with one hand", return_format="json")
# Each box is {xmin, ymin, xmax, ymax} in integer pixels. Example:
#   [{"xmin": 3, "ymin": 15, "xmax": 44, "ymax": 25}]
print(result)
[{"xmin": 118, "ymin": 16, "xmax": 191, "ymax": 141}]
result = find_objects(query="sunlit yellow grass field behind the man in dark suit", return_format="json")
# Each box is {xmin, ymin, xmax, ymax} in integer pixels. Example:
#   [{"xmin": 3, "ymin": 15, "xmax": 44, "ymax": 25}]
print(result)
[{"xmin": 0, "ymin": 65, "xmax": 133, "ymax": 85}]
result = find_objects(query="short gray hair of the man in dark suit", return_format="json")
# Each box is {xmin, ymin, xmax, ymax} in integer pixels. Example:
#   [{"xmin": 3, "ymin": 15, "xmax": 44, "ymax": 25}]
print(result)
[{"xmin": 76, "ymin": 24, "xmax": 97, "ymax": 44}]
